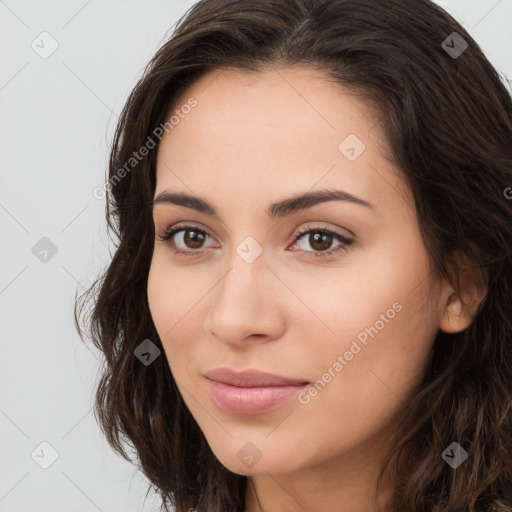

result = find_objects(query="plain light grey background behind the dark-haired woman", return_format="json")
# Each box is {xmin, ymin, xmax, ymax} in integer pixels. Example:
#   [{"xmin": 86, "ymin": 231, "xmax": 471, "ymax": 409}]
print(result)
[{"xmin": 0, "ymin": 0, "xmax": 512, "ymax": 512}]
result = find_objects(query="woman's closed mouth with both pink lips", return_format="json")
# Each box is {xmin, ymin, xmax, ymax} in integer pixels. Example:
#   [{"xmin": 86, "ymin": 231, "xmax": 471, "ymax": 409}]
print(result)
[{"xmin": 204, "ymin": 368, "xmax": 310, "ymax": 415}]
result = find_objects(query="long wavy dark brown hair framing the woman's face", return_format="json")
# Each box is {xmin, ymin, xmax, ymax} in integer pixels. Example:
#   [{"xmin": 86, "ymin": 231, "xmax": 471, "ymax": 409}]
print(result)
[{"xmin": 74, "ymin": 0, "xmax": 512, "ymax": 512}]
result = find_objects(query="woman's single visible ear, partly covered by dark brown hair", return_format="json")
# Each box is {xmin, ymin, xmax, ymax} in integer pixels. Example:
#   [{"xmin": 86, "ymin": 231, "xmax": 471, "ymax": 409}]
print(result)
[{"xmin": 439, "ymin": 267, "xmax": 488, "ymax": 333}]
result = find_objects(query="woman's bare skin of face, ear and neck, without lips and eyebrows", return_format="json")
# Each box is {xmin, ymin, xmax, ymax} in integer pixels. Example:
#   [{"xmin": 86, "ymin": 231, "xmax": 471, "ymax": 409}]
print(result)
[{"xmin": 147, "ymin": 67, "xmax": 481, "ymax": 512}]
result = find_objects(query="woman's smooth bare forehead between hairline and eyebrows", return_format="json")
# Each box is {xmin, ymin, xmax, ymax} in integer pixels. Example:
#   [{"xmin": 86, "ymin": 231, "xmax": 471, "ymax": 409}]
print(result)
[{"xmin": 152, "ymin": 68, "xmax": 408, "ymax": 214}]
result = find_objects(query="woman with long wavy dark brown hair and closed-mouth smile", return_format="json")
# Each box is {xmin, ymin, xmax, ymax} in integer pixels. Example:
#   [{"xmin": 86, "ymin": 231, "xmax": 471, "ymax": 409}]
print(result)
[{"xmin": 75, "ymin": 0, "xmax": 512, "ymax": 512}]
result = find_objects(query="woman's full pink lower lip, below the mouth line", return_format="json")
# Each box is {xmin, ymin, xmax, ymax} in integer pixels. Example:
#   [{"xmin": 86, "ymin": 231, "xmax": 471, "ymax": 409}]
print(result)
[{"xmin": 206, "ymin": 378, "xmax": 308, "ymax": 415}]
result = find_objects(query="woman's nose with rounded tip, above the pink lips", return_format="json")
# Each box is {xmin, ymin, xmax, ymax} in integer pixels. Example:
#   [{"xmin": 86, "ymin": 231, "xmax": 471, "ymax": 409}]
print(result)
[{"xmin": 205, "ymin": 256, "xmax": 285, "ymax": 348}]
